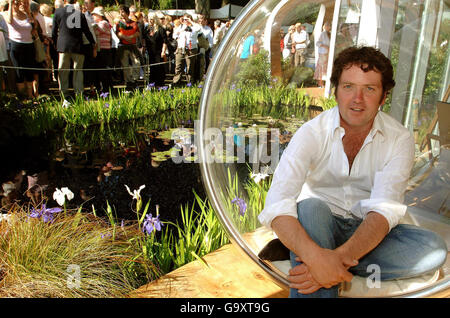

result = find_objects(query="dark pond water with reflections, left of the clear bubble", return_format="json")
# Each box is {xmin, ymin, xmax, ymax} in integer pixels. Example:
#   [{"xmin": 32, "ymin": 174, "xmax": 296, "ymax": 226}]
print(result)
[{"xmin": 0, "ymin": 117, "xmax": 205, "ymax": 225}]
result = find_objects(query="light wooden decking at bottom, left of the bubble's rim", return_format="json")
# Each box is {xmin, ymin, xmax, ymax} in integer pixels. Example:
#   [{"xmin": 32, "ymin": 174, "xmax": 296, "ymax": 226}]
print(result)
[{"xmin": 130, "ymin": 244, "xmax": 289, "ymax": 298}]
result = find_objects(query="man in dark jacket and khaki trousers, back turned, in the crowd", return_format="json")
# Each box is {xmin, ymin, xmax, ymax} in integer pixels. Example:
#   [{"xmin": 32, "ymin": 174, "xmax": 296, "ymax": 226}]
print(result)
[{"xmin": 52, "ymin": 0, "xmax": 95, "ymax": 96}]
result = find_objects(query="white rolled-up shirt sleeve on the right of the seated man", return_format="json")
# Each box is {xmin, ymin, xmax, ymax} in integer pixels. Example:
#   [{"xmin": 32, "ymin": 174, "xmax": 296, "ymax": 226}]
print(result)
[{"xmin": 359, "ymin": 132, "xmax": 414, "ymax": 231}]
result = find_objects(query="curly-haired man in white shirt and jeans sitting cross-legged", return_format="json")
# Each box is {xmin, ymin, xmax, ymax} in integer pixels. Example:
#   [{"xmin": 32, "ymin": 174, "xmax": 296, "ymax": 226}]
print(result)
[{"xmin": 259, "ymin": 47, "xmax": 447, "ymax": 297}]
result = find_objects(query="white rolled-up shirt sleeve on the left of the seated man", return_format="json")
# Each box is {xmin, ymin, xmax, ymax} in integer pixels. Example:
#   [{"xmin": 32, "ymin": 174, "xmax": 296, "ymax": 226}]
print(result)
[{"xmin": 258, "ymin": 125, "xmax": 318, "ymax": 229}]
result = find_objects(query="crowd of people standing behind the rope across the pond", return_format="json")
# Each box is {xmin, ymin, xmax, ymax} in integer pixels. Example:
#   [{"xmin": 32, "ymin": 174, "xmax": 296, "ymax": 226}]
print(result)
[{"xmin": 0, "ymin": 0, "xmax": 233, "ymax": 98}]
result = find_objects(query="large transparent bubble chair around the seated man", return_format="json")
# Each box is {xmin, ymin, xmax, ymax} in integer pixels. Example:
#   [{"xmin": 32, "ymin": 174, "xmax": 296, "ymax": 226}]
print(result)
[{"xmin": 196, "ymin": 0, "xmax": 450, "ymax": 297}]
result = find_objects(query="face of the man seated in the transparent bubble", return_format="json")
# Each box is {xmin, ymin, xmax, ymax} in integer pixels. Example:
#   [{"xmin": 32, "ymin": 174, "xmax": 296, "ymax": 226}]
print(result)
[{"xmin": 336, "ymin": 65, "xmax": 386, "ymax": 130}]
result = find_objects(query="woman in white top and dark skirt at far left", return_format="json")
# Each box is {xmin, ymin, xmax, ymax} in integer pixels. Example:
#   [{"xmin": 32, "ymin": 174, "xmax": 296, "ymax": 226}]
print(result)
[{"xmin": 5, "ymin": 0, "xmax": 37, "ymax": 98}]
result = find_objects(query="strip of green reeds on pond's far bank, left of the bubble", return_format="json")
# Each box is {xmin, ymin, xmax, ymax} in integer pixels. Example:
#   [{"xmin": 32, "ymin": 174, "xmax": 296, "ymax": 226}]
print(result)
[{"xmin": 3, "ymin": 87, "xmax": 201, "ymax": 136}]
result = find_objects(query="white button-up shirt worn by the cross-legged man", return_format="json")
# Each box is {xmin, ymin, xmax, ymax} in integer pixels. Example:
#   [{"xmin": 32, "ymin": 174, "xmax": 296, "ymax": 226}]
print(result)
[{"xmin": 258, "ymin": 106, "xmax": 414, "ymax": 230}]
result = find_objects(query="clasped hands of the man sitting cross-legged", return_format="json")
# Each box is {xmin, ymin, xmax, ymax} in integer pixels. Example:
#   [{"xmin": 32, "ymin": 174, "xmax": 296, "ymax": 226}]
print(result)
[{"xmin": 288, "ymin": 248, "xmax": 358, "ymax": 294}]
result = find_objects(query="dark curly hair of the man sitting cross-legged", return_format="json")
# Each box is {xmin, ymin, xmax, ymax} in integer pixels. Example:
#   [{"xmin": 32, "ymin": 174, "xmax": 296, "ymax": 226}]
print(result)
[{"xmin": 330, "ymin": 46, "xmax": 395, "ymax": 96}]
